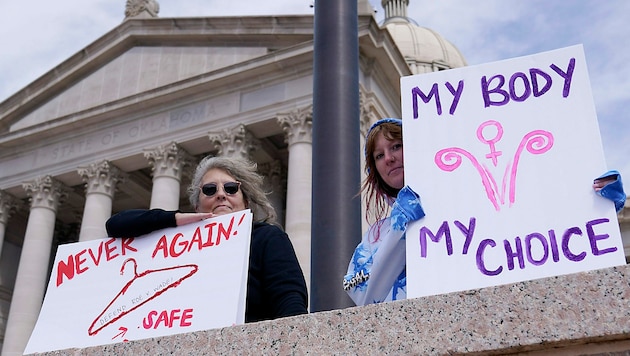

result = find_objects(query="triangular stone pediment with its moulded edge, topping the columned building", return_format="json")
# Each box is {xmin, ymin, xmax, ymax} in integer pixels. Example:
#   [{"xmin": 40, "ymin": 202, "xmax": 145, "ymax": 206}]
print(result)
[{"xmin": 0, "ymin": 16, "xmax": 313, "ymax": 135}]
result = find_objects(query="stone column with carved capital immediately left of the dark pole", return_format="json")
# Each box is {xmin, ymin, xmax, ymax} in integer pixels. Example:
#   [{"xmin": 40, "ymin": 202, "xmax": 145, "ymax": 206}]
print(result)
[{"xmin": 278, "ymin": 106, "xmax": 314, "ymax": 288}]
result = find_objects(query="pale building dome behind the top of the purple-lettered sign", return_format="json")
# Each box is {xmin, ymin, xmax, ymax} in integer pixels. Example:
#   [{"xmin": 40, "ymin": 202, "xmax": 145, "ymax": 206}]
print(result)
[{"xmin": 382, "ymin": 0, "xmax": 467, "ymax": 74}]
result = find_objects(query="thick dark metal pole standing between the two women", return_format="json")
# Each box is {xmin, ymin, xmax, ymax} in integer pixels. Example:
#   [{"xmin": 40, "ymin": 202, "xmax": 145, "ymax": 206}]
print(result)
[{"xmin": 311, "ymin": 0, "xmax": 361, "ymax": 312}]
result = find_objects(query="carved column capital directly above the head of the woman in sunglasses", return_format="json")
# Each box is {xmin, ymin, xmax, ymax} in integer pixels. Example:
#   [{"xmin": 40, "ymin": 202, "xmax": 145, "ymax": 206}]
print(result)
[{"xmin": 208, "ymin": 124, "xmax": 260, "ymax": 159}]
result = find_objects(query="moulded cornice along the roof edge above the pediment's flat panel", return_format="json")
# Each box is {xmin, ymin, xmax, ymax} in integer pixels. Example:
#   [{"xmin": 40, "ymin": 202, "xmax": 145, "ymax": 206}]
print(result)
[{"xmin": 0, "ymin": 15, "xmax": 313, "ymax": 133}]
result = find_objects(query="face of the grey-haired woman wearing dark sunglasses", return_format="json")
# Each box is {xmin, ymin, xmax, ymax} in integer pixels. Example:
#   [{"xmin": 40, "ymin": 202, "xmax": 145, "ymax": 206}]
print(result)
[{"xmin": 197, "ymin": 168, "xmax": 247, "ymax": 215}]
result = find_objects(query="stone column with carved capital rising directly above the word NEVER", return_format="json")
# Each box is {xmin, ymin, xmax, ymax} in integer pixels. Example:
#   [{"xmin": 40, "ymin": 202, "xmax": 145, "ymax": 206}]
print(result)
[{"xmin": 78, "ymin": 161, "xmax": 126, "ymax": 241}]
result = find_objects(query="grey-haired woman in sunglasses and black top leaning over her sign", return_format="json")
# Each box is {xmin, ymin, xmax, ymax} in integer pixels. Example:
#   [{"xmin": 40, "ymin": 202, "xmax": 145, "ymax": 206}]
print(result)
[{"xmin": 106, "ymin": 157, "xmax": 308, "ymax": 322}]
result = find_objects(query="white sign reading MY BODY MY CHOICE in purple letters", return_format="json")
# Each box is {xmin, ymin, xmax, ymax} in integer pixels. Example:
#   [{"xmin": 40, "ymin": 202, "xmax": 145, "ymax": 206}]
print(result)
[{"xmin": 401, "ymin": 45, "xmax": 625, "ymax": 298}]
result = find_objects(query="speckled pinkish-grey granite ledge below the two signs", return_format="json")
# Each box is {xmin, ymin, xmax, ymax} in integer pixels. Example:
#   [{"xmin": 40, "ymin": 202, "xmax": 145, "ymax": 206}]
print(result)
[{"xmin": 34, "ymin": 265, "xmax": 630, "ymax": 355}]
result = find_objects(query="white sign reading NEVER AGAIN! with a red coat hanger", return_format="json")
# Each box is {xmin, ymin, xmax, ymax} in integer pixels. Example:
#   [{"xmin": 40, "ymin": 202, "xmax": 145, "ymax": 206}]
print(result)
[{"xmin": 25, "ymin": 210, "xmax": 252, "ymax": 353}]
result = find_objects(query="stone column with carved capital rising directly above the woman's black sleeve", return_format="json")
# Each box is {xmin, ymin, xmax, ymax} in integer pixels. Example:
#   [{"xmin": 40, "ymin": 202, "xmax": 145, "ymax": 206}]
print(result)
[{"xmin": 144, "ymin": 142, "xmax": 193, "ymax": 210}]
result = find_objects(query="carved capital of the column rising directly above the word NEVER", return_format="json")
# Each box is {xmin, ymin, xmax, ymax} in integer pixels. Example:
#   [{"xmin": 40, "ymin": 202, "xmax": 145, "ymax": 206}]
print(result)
[{"xmin": 77, "ymin": 160, "xmax": 127, "ymax": 198}]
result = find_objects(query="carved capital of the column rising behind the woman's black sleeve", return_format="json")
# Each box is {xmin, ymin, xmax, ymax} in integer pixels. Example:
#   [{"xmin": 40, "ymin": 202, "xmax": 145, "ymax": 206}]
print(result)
[{"xmin": 144, "ymin": 142, "xmax": 194, "ymax": 181}]
